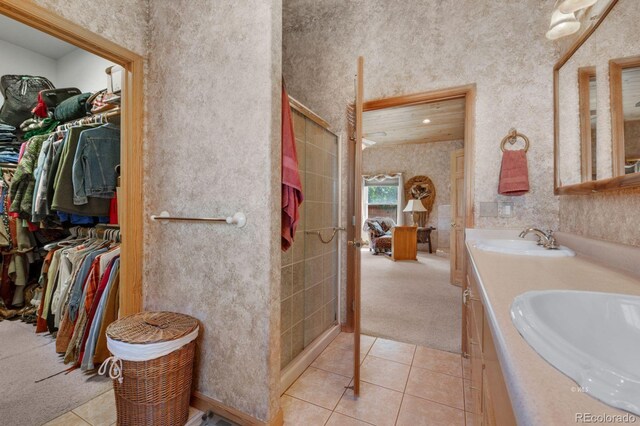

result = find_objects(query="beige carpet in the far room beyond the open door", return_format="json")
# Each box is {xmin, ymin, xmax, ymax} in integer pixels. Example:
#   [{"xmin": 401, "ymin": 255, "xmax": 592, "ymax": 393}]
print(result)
[{"xmin": 361, "ymin": 251, "xmax": 462, "ymax": 353}]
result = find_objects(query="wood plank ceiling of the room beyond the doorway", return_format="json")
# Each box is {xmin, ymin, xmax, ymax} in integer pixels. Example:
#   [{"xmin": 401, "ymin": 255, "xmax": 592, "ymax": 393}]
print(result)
[{"xmin": 362, "ymin": 99, "xmax": 465, "ymax": 148}]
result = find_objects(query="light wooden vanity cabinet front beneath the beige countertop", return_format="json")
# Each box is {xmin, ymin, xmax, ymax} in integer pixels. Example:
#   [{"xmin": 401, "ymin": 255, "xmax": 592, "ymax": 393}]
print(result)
[{"xmin": 463, "ymin": 255, "xmax": 516, "ymax": 426}]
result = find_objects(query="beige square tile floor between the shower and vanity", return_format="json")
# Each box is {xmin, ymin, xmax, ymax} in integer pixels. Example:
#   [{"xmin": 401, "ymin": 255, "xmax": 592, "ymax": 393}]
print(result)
[{"xmin": 281, "ymin": 333, "xmax": 472, "ymax": 426}]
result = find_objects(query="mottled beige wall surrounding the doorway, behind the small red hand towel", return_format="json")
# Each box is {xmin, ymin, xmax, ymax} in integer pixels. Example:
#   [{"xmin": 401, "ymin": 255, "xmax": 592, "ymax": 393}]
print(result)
[{"xmin": 283, "ymin": 0, "xmax": 558, "ymax": 318}]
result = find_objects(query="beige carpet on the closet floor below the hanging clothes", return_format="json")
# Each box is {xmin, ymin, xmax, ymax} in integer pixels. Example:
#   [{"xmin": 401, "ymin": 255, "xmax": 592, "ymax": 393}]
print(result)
[{"xmin": 0, "ymin": 320, "xmax": 112, "ymax": 426}]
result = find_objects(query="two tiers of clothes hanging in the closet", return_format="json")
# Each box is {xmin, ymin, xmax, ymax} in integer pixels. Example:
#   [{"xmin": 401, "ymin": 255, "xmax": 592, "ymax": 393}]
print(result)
[{"xmin": 0, "ymin": 82, "xmax": 120, "ymax": 376}]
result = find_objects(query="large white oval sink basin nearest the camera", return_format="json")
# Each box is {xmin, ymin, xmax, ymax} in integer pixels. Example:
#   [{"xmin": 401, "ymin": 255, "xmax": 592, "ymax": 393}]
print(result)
[{"xmin": 511, "ymin": 290, "xmax": 640, "ymax": 415}]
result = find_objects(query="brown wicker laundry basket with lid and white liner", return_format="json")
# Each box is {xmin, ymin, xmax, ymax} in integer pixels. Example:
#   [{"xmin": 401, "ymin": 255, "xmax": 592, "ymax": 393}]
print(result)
[{"xmin": 101, "ymin": 312, "xmax": 198, "ymax": 426}]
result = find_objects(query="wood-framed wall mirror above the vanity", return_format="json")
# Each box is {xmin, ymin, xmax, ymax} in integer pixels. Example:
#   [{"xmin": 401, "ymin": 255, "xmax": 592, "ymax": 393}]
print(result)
[{"xmin": 554, "ymin": 0, "xmax": 640, "ymax": 194}]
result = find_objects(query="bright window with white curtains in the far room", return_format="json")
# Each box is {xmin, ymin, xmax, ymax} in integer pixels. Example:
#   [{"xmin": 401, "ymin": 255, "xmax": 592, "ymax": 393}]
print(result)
[{"xmin": 362, "ymin": 174, "xmax": 402, "ymax": 224}]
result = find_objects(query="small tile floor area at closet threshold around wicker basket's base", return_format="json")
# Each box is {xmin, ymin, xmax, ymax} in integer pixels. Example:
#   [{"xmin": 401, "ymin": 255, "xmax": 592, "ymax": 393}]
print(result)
[{"xmin": 45, "ymin": 389, "xmax": 203, "ymax": 426}]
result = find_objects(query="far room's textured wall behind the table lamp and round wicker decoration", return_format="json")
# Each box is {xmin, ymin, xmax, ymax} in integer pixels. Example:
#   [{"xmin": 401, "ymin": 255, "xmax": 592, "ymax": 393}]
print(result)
[{"xmin": 362, "ymin": 141, "xmax": 463, "ymax": 231}]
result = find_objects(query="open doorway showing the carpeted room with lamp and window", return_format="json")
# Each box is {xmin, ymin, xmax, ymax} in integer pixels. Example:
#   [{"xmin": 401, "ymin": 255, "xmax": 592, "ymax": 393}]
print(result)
[{"xmin": 361, "ymin": 98, "xmax": 465, "ymax": 353}]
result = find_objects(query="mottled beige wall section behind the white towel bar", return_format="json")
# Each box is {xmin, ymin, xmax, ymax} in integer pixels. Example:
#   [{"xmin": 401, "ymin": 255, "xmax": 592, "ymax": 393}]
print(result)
[{"xmin": 144, "ymin": 0, "xmax": 282, "ymax": 420}]
